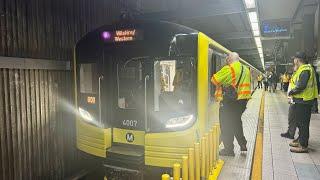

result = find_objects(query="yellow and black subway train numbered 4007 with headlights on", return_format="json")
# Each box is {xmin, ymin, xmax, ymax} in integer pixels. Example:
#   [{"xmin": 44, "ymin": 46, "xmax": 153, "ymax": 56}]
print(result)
[{"xmin": 73, "ymin": 21, "xmax": 259, "ymax": 179}]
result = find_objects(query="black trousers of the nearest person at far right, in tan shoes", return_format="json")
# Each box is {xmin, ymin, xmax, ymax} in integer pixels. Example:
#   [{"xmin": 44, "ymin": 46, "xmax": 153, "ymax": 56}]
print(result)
[{"xmin": 294, "ymin": 104, "xmax": 312, "ymax": 147}]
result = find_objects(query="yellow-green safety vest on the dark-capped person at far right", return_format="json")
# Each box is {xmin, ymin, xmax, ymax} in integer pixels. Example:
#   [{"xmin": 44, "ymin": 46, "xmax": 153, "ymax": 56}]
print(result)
[{"xmin": 290, "ymin": 64, "xmax": 318, "ymax": 101}]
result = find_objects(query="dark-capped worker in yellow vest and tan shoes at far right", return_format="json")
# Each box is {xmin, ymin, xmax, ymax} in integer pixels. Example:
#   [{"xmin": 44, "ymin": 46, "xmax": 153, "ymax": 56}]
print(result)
[{"xmin": 288, "ymin": 52, "xmax": 318, "ymax": 153}]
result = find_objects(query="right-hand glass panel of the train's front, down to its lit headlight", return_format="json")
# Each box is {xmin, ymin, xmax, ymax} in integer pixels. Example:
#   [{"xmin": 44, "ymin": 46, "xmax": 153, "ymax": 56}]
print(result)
[{"xmin": 153, "ymin": 58, "xmax": 195, "ymax": 130}]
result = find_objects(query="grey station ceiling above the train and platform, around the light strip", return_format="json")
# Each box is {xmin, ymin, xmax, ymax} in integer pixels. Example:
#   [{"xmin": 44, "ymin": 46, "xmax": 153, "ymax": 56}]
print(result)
[{"xmin": 141, "ymin": 0, "xmax": 314, "ymax": 69}]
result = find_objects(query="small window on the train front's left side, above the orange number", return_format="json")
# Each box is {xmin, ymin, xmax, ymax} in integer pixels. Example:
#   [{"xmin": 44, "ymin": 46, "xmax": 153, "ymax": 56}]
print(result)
[{"xmin": 80, "ymin": 63, "xmax": 97, "ymax": 94}]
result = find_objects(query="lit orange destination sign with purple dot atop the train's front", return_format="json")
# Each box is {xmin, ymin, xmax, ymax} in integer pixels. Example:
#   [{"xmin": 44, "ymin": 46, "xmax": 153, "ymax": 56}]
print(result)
[{"xmin": 101, "ymin": 29, "xmax": 143, "ymax": 42}]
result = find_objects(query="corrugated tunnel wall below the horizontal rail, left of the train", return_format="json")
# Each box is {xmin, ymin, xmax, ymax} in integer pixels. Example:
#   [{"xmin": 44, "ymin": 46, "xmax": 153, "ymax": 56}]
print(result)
[{"xmin": 0, "ymin": 68, "xmax": 91, "ymax": 180}]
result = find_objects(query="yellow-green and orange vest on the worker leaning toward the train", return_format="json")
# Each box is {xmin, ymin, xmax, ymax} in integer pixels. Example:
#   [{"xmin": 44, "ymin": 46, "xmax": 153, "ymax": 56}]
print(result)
[{"xmin": 211, "ymin": 61, "xmax": 251, "ymax": 100}]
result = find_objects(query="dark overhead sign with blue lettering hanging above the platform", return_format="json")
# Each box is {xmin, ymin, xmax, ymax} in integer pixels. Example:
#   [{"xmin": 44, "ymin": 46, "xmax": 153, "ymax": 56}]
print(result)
[{"xmin": 261, "ymin": 20, "xmax": 290, "ymax": 37}]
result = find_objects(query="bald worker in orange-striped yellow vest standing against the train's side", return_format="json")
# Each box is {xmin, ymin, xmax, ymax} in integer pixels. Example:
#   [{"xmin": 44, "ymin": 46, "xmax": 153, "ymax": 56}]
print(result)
[{"xmin": 211, "ymin": 52, "xmax": 251, "ymax": 156}]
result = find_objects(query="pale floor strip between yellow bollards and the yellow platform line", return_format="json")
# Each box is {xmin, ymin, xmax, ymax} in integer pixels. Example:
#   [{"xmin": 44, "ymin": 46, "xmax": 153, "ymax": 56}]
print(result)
[{"xmin": 219, "ymin": 90, "xmax": 262, "ymax": 180}]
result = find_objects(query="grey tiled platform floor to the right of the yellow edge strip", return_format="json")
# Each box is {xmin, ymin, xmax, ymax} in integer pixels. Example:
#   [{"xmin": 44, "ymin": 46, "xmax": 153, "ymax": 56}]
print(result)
[{"xmin": 263, "ymin": 92, "xmax": 320, "ymax": 180}]
